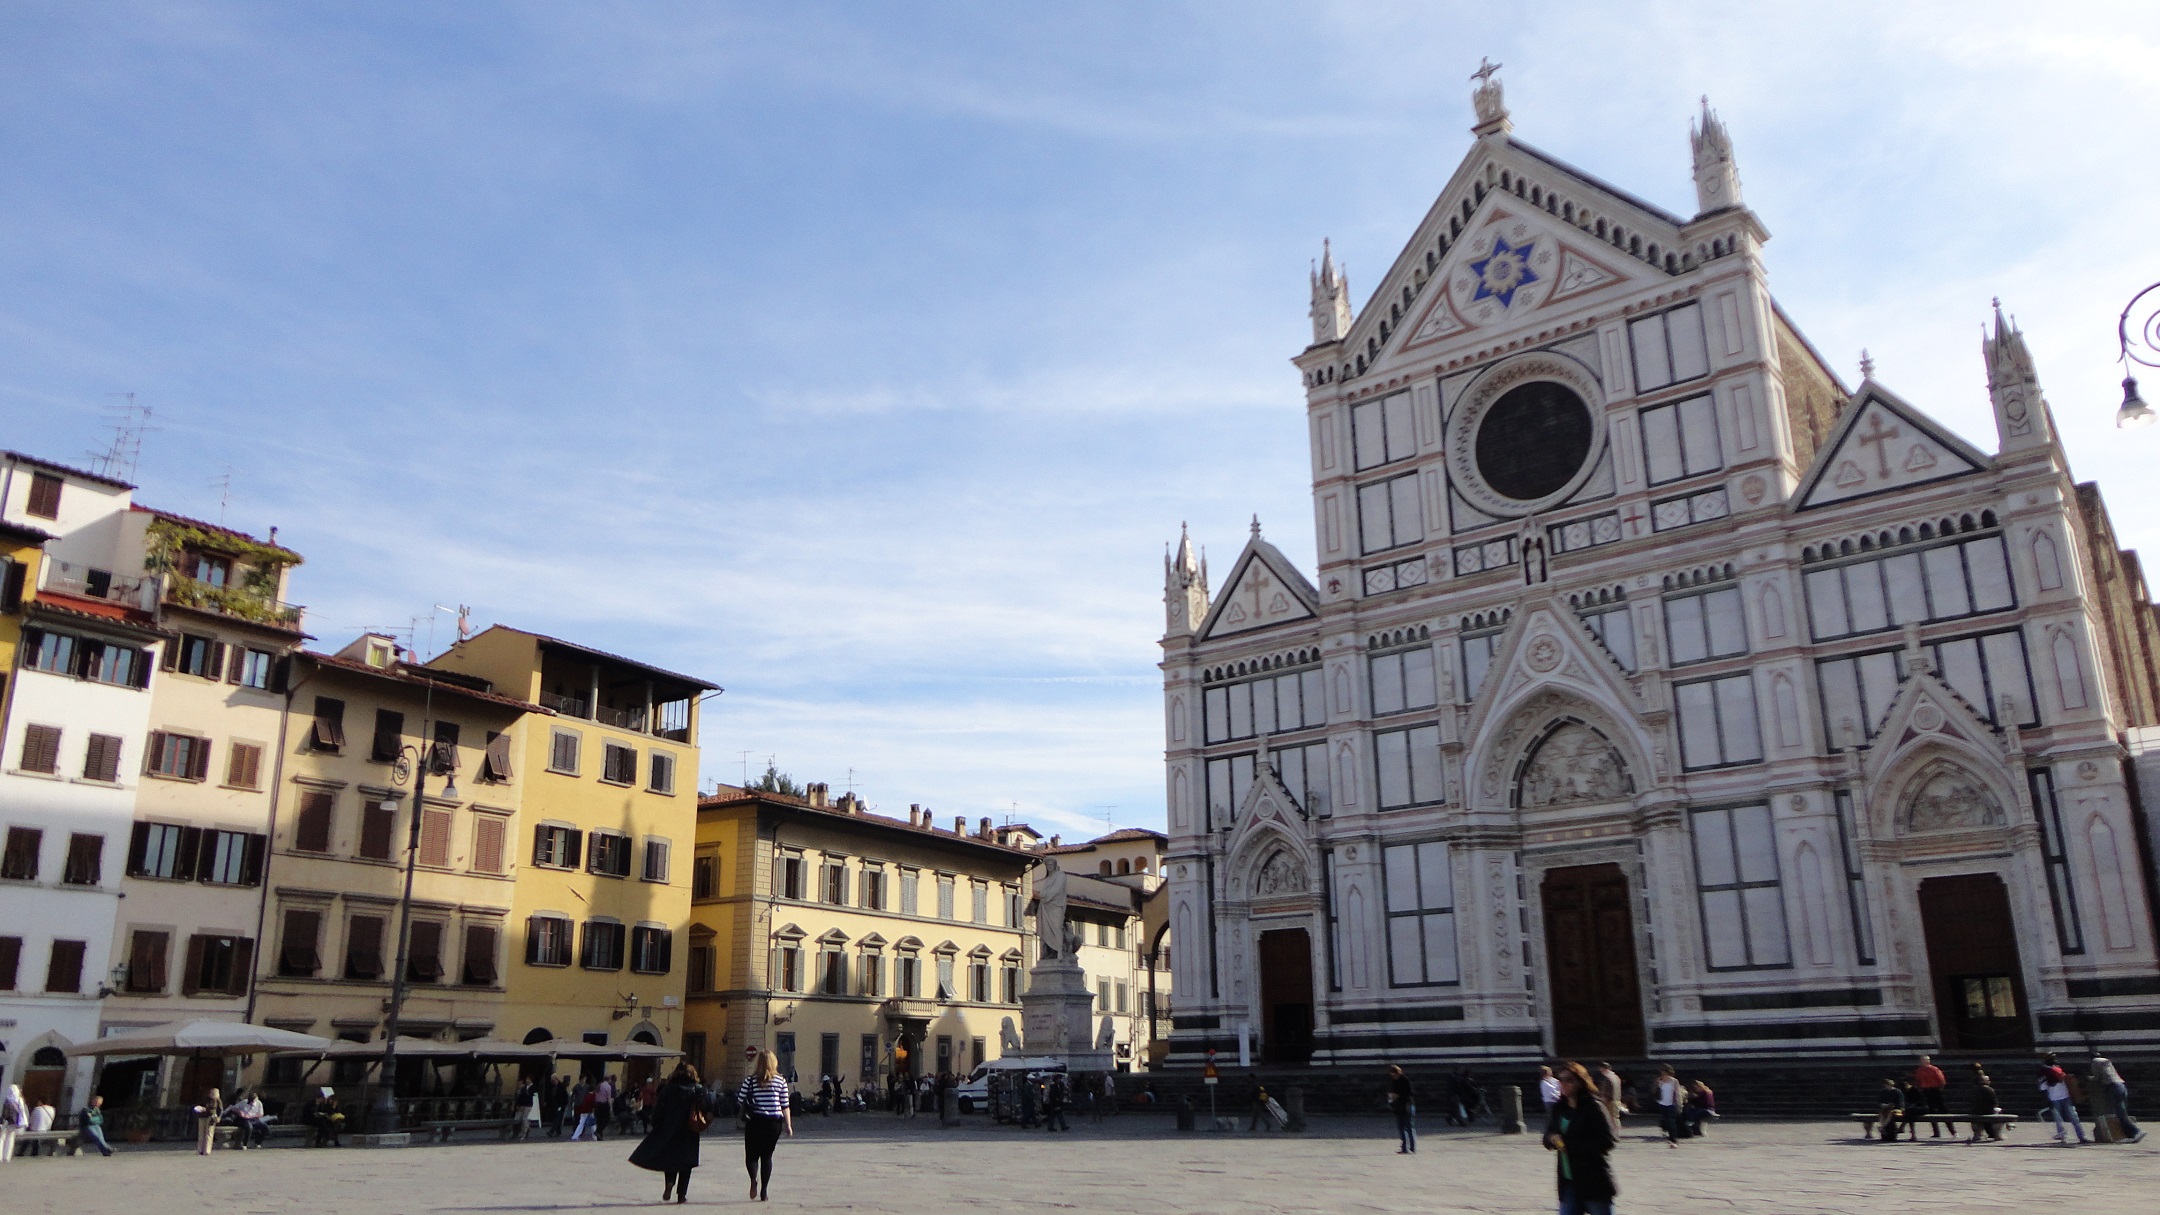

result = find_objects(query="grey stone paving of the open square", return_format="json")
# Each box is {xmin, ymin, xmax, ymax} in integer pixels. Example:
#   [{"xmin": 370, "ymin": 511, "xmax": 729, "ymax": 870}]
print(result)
[{"xmin": 0, "ymin": 1116, "xmax": 2160, "ymax": 1215}]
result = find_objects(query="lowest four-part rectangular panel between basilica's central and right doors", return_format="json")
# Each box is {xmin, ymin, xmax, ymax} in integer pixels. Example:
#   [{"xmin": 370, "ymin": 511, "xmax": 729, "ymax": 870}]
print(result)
[{"xmin": 1689, "ymin": 804, "xmax": 1793, "ymax": 971}]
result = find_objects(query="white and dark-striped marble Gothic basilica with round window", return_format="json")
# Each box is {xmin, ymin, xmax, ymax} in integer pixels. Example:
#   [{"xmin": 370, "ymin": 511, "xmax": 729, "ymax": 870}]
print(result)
[{"xmin": 1162, "ymin": 78, "xmax": 2160, "ymax": 1066}]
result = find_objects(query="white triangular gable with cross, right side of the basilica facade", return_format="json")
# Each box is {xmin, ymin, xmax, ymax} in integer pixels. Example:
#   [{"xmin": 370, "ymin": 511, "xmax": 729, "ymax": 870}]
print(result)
[{"xmin": 1793, "ymin": 380, "xmax": 1989, "ymax": 510}]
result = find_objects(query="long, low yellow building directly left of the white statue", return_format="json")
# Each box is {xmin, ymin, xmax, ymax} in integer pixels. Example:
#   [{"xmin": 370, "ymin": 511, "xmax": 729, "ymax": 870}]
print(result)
[{"xmin": 685, "ymin": 785, "xmax": 1035, "ymax": 1092}]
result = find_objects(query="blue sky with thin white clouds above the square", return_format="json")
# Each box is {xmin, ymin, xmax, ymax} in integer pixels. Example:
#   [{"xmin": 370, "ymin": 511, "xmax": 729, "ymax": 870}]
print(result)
[{"xmin": 0, "ymin": 0, "xmax": 2160, "ymax": 837}]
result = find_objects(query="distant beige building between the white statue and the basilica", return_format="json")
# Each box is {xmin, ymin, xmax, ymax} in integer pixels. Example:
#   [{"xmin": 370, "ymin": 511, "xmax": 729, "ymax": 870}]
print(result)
[{"xmin": 1041, "ymin": 828, "xmax": 1171, "ymax": 1070}]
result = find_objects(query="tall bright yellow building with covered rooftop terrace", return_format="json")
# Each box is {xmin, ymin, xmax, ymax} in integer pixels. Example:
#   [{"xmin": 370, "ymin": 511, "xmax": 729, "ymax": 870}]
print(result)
[{"xmin": 428, "ymin": 625, "xmax": 717, "ymax": 1046}]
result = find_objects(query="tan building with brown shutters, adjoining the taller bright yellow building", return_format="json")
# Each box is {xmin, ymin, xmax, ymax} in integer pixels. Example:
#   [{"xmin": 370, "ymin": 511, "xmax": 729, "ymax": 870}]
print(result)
[{"xmin": 247, "ymin": 633, "xmax": 549, "ymax": 1096}]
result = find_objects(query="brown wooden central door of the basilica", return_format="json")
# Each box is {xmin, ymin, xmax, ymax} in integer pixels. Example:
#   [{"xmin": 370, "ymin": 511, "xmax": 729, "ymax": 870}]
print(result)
[{"xmin": 1540, "ymin": 865, "xmax": 1644, "ymax": 1059}]
